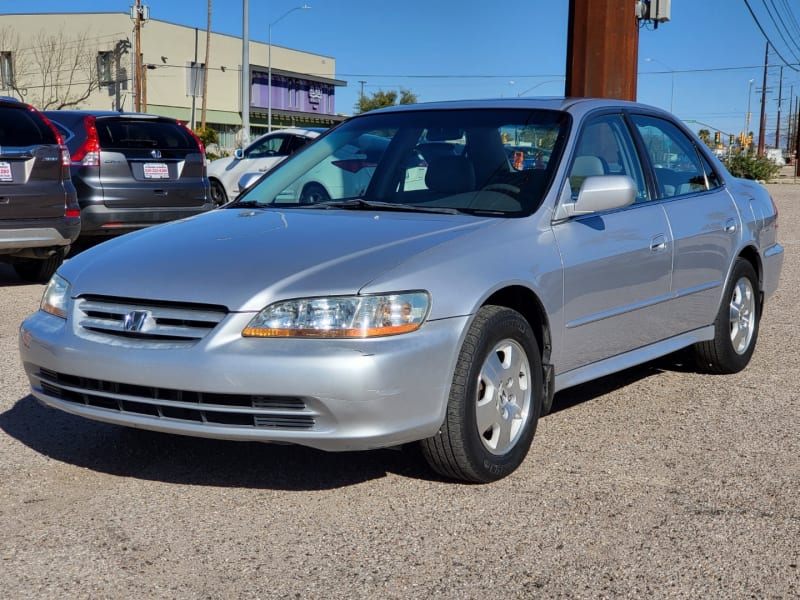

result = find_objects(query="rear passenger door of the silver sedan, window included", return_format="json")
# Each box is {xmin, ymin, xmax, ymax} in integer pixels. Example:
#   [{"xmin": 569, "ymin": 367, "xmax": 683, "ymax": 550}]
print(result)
[{"xmin": 631, "ymin": 114, "xmax": 742, "ymax": 331}]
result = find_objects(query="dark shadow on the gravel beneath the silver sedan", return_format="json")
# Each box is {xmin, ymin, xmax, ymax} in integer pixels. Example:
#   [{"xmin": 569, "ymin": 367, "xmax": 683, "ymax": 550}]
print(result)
[{"xmin": 0, "ymin": 355, "xmax": 682, "ymax": 491}]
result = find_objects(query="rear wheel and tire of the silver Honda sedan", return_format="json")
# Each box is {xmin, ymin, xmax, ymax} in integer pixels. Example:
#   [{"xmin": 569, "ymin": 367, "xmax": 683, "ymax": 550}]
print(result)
[{"xmin": 693, "ymin": 258, "xmax": 761, "ymax": 373}]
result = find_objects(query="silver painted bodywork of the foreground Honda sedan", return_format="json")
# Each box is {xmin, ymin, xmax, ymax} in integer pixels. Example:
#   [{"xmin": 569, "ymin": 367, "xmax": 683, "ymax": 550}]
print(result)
[{"xmin": 20, "ymin": 100, "xmax": 783, "ymax": 450}]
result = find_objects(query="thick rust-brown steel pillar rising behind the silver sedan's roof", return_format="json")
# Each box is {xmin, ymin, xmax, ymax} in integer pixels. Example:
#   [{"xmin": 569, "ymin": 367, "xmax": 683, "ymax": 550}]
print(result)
[{"xmin": 565, "ymin": 0, "xmax": 639, "ymax": 100}]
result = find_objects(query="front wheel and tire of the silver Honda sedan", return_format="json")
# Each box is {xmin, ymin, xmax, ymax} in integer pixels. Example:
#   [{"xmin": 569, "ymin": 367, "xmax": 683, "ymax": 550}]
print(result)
[{"xmin": 420, "ymin": 306, "xmax": 544, "ymax": 483}]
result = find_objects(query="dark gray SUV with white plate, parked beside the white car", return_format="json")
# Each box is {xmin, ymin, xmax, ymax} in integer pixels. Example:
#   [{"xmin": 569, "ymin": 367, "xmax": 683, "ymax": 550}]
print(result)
[{"xmin": 45, "ymin": 110, "xmax": 214, "ymax": 237}]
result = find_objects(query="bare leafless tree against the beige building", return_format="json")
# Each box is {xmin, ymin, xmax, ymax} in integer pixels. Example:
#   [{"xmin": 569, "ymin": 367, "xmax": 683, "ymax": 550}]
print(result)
[{"xmin": 0, "ymin": 27, "xmax": 100, "ymax": 110}]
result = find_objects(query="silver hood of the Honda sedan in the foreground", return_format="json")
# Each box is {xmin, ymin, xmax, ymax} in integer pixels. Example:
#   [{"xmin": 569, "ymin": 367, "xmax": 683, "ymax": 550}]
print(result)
[{"xmin": 59, "ymin": 208, "xmax": 497, "ymax": 311}]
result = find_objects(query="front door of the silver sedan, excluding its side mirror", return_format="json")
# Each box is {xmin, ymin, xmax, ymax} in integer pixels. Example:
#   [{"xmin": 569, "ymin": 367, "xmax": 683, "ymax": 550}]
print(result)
[{"xmin": 553, "ymin": 114, "xmax": 673, "ymax": 374}]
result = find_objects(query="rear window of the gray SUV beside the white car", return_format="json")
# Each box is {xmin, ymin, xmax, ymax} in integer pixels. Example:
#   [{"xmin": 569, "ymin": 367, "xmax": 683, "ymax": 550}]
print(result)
[{"xmin": 95, "ymin": 119, "xmax": 198, "ymax": 150}]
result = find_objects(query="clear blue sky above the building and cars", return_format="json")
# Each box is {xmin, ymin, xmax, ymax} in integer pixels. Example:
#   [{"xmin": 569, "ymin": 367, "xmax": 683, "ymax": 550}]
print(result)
[{"xmin": 0, "ymin": 0, "xmax": 800, "ymax": 142}]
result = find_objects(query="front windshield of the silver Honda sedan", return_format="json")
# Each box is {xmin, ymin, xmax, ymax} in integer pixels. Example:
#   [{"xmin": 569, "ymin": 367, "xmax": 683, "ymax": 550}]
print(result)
[{"xmin": 229, "ymin": 109, "xmax": 569, "ymax": 216}]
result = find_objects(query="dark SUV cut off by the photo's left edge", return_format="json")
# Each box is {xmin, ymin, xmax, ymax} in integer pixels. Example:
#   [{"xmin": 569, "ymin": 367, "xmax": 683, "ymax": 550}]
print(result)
[{"xmin": 0, "ymin": 98, "xmax": 81, "ymax": 282}]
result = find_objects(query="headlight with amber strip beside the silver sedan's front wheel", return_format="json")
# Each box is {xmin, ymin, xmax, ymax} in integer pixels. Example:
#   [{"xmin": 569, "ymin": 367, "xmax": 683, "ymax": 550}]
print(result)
[{"xmin": 242, "ymin": 292, "xmax": 430, "ymax": 338}]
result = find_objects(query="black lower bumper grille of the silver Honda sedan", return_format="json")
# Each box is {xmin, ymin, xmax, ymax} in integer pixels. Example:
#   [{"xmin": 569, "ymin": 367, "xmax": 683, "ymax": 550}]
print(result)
[{"xmin": 37, "ymin": 369, "xmax": 315, "ymax": 430}]
